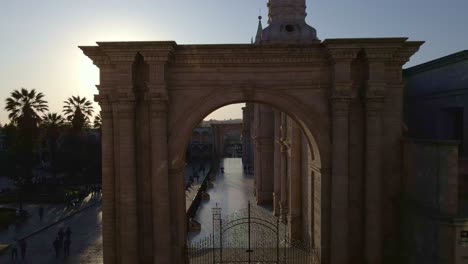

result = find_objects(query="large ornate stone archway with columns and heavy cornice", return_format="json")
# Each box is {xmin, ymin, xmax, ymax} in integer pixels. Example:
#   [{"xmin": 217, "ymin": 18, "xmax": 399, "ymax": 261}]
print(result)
[{"xmin": 81, "ymin": 38, "xmax": 422, "ymax": 264}]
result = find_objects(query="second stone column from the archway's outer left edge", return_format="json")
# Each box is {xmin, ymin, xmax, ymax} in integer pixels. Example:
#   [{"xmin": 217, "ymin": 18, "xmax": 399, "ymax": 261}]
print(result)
[{"xmin": 115, "ymin": 98, "xmax": 139, "ymax": 264}]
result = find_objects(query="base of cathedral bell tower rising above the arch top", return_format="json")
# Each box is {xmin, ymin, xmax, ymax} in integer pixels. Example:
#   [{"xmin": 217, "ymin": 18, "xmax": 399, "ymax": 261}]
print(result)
[{"xmin": 261, "ymin": 0, "xmax": 319, "ymax": 44}]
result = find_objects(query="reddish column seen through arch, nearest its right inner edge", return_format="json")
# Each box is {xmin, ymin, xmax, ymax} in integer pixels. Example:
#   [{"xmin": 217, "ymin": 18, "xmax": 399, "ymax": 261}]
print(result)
[{"xmin": 288, "ymin": 120, "xmax": 302, "ymax": 240}]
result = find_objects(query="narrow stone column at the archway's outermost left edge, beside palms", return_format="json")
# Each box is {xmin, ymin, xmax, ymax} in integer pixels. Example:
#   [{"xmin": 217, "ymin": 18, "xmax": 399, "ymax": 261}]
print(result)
[{"xmin": 96, "ymin": 95, "xmax": 117, "ymax": 263}]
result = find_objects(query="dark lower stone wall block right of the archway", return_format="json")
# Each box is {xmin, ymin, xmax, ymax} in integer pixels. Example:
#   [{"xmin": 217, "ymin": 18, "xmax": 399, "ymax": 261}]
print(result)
[{"xmin": 400, "ymin": 140, "xmax": 463, "ymax": 264}]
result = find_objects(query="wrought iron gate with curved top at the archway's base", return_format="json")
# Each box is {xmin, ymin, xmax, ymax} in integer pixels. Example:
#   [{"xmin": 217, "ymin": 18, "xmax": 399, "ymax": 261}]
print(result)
[{"xmin": 188, "ymin": 203, "xmax": 319, "ymax": 264}]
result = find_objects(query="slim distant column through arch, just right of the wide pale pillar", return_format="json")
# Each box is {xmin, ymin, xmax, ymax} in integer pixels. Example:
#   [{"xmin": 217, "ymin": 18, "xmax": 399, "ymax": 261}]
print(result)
[{"xmin": 273, "ymin": 111, "xmax": 281, "ymax": 217}]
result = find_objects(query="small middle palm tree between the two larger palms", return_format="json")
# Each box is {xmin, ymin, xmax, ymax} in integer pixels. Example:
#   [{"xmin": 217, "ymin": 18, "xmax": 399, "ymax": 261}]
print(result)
[{"xmin": 42, "ymin": 113, "xmax": 65, "ymax": 177}]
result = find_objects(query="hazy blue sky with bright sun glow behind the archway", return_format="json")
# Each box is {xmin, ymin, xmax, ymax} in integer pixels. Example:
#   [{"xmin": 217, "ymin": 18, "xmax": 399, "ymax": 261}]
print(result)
[{"xmin": 0, "ymin": 0, "xmax": 468, "ymax": 123}]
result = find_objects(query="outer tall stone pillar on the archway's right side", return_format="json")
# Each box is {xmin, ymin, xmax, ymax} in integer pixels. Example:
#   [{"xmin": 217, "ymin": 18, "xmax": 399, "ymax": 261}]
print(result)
[{"xmin": 365, "ymin": 52, "xmax": 386, "ymax": 264}]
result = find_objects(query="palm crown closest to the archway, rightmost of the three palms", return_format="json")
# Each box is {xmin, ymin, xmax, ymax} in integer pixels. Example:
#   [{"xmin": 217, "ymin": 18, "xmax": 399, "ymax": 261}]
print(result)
[{"xmin": 63, "ymin": 96, "xmax": 93, "ymax": 131}]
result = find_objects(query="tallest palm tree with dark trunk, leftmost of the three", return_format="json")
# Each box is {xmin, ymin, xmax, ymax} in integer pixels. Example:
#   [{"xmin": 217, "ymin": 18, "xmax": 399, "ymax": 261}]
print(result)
[{"xmin": 5, "ymin": 88, "xmax": 48, "ymax": 208}]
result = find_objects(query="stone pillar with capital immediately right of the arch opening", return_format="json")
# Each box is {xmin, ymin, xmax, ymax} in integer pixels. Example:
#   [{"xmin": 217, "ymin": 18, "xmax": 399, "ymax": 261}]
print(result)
[{"xmin": 327, "ymin": 44, "xmax": 359, "ymax": 264}]
